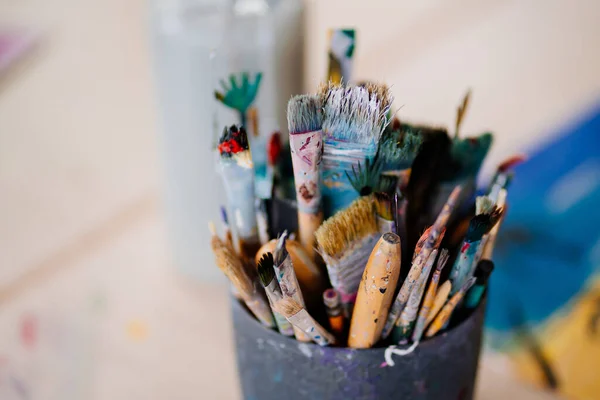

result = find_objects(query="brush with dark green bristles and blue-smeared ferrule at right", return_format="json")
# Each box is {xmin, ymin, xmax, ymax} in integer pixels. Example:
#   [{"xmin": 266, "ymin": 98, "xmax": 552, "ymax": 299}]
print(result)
[{"xmin": 450, "ymin": 196, "xmax": 504, "ymax": 294}]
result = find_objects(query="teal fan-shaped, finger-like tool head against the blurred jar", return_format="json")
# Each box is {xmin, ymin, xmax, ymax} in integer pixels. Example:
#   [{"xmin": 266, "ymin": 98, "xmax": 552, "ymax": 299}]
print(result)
[{"xmin": 214, "ymin": 72, "xmax": 262, "ymax": 126}]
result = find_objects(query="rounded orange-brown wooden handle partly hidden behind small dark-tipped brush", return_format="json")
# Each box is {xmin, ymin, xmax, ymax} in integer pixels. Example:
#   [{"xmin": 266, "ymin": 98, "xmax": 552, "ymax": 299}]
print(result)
[{"xmin": 254, "ymin": 238, "xmax": 327, "ymax": 310}]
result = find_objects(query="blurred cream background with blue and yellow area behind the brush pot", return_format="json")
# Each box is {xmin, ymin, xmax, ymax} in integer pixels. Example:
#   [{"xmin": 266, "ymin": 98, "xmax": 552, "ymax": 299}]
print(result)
[{"xmin": 0, "ymin": 0, "xmax": 600, "ymax": 400}]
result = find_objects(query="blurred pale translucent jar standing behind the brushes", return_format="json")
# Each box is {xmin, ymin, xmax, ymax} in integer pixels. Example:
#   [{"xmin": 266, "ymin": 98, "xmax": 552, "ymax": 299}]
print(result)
[{"xmin": 150, "ymin": 0, "xmax": 303, "ymax": 280}]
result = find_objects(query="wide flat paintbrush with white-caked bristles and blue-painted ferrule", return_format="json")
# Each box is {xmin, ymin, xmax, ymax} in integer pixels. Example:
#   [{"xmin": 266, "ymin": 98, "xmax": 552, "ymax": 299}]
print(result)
[{"xmin": 322, "ymin": 84, "xmax": 393, "ymax": 218}]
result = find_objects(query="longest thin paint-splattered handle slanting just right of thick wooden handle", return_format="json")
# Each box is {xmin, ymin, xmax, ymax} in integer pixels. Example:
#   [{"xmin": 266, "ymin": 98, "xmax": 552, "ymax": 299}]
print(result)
[{"xmin": 382, "ymin": 186, "xmax": 461, "ymax": 339}]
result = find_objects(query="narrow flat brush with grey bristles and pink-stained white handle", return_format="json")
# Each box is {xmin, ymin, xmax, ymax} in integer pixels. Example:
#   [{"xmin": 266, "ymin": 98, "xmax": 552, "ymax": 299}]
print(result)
[{"xmin": 287, "ymin": 95, "xmax": 323, "ymax": 258}]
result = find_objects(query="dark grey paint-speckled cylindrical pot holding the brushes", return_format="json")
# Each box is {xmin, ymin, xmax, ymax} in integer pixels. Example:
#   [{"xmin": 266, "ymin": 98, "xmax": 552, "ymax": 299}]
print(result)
[{"xmin": 232, "ymin": 301, "xmax": 485, "ymax": 400}]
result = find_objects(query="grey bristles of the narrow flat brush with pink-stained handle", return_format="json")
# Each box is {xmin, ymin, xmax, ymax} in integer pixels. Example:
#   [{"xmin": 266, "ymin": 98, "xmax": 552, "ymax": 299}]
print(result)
[{"xmin": 287, "ymin": 94, "xmax": 323, "ymax": 134}]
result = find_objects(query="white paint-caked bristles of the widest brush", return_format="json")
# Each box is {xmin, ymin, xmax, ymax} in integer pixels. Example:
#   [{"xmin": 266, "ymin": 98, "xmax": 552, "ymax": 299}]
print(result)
[{"xmin": 323, "ymin": 86, "xmax": 393, "ymax": 144}]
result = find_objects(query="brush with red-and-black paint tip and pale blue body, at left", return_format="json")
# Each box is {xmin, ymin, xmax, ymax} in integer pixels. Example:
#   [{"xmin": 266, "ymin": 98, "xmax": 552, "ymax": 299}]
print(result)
[{"xmin": 218, "ymin": 125, "xmax": 260, "ymax": 259}]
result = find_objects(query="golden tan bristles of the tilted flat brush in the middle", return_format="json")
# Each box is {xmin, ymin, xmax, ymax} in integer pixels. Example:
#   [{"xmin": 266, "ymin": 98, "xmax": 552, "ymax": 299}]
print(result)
[{"xmin": 315, "ymin": 196, "xmax": 377, "ymax": 257}]
